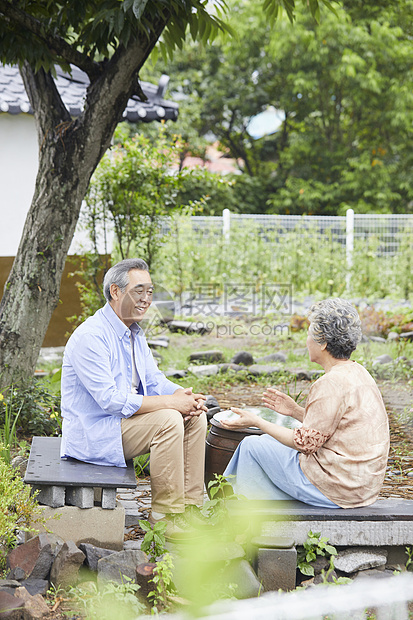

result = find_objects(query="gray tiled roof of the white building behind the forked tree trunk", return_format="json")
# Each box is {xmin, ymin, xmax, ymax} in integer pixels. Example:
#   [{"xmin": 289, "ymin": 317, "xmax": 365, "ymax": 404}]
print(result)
[{"xmin": 0, "ymin": 65, "xmax": 178, "ymax": 123}]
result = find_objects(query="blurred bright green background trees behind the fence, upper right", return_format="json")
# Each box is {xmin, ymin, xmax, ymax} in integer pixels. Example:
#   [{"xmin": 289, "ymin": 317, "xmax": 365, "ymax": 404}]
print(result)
[{"xmin": 146, "ymin": 0, "xmax": 413, "ymax": 214}]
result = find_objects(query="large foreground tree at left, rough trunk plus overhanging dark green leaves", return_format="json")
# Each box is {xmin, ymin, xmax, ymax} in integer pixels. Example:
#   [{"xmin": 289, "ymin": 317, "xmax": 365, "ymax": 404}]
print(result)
[{"xmin": 0, "ymin": 0, "xmax": 329, "ymax": 385}]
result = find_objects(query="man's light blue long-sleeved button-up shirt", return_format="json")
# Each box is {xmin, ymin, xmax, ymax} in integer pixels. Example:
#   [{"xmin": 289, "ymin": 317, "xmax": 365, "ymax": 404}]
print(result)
[{"xmin": 61, "ymin": 304, "xmax": 180, "ymax": 467}]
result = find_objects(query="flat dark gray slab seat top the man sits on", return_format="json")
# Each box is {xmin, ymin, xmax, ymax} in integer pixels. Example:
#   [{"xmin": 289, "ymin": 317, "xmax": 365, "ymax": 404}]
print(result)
[{"xmin": 24, "ymin": 437, "xmax": 136, "ymax": 489}]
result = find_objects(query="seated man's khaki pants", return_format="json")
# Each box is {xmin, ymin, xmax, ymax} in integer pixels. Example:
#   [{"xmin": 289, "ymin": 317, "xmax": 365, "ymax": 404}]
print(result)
[{"xmin": 122, "ymin": 409, "xmax": 206, "ymax": 513}]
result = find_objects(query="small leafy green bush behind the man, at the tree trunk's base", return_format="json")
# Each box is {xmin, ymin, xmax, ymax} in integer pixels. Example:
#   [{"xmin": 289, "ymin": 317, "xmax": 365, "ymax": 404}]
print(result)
[{"xmin": 0, "ymin": 379, "xmax": 60, "ymax": 435}]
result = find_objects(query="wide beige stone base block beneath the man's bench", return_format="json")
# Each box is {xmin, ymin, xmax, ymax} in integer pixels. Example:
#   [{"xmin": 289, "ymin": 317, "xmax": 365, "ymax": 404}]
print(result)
[{"xmin": 29, "ymin": 506, "xmax": 125, "ymax": 551}]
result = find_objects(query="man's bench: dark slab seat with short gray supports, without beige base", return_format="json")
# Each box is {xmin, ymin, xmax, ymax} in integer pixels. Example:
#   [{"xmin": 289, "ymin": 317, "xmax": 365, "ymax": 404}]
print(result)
[{"xmin": 24, "ymin": 437, "xmax": 136, "ymax": 509}]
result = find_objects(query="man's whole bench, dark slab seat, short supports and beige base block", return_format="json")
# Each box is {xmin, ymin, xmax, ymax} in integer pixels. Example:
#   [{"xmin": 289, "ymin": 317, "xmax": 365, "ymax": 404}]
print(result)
[{"xmin": 24, "ymin": 437, "xmax": 137, "ymax": 551}]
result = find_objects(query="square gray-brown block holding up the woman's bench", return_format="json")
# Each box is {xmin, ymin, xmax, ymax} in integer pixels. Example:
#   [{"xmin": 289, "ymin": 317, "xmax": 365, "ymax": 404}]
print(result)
[{"xmin": 257, "ymin": 547, "xmax": 297, "ymax": 592}]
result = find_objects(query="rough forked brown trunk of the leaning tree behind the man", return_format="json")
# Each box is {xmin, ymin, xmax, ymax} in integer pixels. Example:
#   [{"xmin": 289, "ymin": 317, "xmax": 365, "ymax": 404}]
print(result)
[{"xmin": 0, "ymin": 21, "xmax": 165, "ymax": 388}]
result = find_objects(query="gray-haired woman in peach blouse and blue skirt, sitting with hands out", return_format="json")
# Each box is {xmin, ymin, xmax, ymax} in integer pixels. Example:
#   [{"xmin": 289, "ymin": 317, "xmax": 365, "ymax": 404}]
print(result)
[{"xmin": 221, "ymin": 299, "xmax": 389, "ymax": 508}]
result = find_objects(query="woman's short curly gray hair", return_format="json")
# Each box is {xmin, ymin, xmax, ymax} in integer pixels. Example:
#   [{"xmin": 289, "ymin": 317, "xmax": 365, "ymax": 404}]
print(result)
[{"xmin": 308, "ymin": 297, "xmax": 361, "ymax": 359}]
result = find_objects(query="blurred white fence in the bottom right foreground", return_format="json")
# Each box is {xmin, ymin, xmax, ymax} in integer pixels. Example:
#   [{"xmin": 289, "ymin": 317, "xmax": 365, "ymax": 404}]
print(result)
[{"xmin": 155, "ymin": 573, "xmax": 413, "ymax": 620}]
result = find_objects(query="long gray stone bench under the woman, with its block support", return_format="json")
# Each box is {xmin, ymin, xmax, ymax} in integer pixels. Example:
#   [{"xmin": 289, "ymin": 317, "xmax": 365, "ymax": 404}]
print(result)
[{"xmin": 228, "ymin": 499, "xmax": 413, "ymax": 590}]
